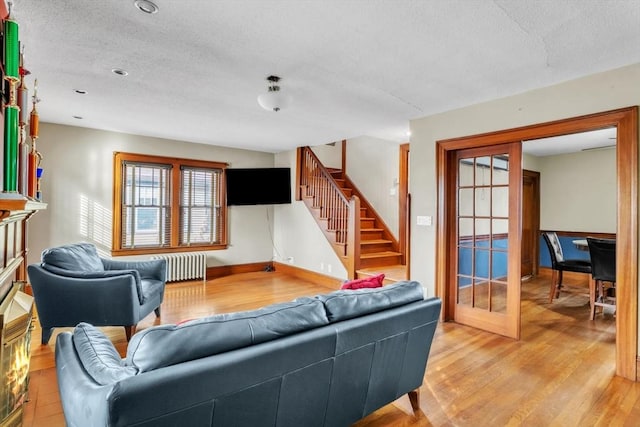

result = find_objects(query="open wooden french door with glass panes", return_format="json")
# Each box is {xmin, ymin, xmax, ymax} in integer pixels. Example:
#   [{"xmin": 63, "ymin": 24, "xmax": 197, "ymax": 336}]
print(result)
[{"xmin": 448, "ymin": 142, "xmax": 522, "ymax": 339}]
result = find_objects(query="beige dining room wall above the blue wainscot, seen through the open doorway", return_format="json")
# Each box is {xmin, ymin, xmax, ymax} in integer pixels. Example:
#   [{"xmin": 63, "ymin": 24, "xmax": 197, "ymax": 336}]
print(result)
[{"xmin": 538, "ymin": 148, "xmax": 617, "ymax": 233}]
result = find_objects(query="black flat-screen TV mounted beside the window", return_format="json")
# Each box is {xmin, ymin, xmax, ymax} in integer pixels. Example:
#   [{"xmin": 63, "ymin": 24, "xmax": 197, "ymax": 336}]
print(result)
[{"xmin": 225, "ymin": 168, "xmax": 291, "ymax": 206}]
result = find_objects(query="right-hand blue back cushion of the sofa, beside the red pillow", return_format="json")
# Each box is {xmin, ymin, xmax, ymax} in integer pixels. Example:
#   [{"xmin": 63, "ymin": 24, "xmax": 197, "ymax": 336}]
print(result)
[{"xmin": 316, "ymin": 281, "xmax": 424, "ymax": 322}]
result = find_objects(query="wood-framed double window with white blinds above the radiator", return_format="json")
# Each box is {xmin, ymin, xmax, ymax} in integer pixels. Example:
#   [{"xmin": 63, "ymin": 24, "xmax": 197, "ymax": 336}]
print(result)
[{"xmin": 112, "ymin": 153, "xmax": 227, "ymax": 255}]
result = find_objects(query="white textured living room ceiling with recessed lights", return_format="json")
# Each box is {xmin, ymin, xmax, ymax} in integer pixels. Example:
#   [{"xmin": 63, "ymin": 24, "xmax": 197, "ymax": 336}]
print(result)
[{"xmin": 12, "ymin": 0, "xmax": 640, "ymax": 152}]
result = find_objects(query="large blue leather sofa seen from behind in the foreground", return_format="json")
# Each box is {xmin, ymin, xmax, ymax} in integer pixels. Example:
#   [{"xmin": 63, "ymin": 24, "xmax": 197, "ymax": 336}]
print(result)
[{"xmin": 56, "ymin": 281, "xmax": 441, "ymax": 427}]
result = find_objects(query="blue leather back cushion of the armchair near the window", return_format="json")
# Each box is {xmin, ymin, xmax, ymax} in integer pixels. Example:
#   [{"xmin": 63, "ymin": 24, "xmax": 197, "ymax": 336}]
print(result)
[{"xmin": 42, "ymin": 243, "xmax": 104, "ymax": 272}]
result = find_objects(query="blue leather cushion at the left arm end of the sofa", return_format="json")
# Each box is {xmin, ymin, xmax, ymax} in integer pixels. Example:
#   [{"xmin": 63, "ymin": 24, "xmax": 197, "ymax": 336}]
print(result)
[{"xmin": 73, "ymin": 322, "xmax": 137, "ymax": 385}]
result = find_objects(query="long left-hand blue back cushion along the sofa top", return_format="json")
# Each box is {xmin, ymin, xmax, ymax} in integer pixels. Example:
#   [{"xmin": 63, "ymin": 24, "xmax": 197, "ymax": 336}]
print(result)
[{"xmin": 125, "ymin": 298, "xmax": 329, "ymax": 372}]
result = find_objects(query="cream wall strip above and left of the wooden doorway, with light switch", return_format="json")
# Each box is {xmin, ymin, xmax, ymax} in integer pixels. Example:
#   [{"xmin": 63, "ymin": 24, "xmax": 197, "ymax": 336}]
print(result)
[{"xmin": 410, "ymin": 64, "xmax": 640, "ymax": 296}]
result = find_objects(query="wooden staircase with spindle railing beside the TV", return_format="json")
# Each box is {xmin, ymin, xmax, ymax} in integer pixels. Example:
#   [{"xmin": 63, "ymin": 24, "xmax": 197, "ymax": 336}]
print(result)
[{"xmin": 298, "ymin": 147, "xmax": 404, "ymax": 278}]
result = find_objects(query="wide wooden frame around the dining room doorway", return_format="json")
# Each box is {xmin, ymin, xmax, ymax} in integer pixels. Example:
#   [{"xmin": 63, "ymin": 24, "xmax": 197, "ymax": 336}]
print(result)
[{"xmin": 436, "ymin": 106, "xmax": 640, "ymax": 381}]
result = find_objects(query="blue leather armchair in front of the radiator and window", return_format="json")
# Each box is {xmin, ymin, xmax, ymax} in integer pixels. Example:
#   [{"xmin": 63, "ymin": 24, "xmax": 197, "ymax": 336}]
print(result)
[{"xmin": 27, "ymin": 243, "xmax": 167, "ymax": 344}]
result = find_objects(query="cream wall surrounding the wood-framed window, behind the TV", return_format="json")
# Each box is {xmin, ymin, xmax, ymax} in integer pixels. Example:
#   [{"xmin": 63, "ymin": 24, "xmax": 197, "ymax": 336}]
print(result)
[{"xmin": 28, "ymin": 123, "xmax": 274, "ymax": 266}]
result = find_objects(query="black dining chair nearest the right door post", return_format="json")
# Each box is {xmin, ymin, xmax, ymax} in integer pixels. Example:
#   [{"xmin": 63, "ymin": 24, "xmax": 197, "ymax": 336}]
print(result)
[{"xmin": 587, "ymin": 237, "xmax": 616, "ymax": 320}]
